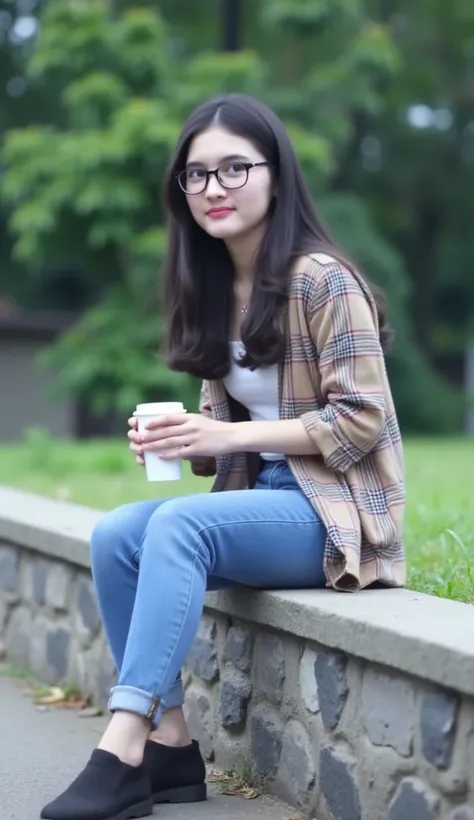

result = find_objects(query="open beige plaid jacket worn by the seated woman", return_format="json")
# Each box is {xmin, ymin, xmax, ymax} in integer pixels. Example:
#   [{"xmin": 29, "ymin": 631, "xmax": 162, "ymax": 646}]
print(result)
[{"xmin": 194, "ymin": 254, "xmax": 406, "ymax": 591}]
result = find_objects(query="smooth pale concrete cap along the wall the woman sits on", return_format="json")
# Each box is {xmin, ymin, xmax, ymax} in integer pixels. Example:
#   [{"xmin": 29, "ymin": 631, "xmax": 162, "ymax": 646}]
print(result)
[{"xmin": 0, "ymin": 487, "xmax": 474, "ymax": 696}]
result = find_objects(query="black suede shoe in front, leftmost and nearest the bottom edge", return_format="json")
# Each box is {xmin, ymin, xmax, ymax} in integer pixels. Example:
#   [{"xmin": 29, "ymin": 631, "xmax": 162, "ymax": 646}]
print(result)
[{"xmin": 41, "ymin": 749, "xmax": 153, "ymax": 820}]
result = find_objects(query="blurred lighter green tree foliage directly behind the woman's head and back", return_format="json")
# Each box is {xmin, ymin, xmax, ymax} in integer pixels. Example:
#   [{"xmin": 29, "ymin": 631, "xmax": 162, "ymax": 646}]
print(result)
[{"xmin": 2, "ymin": 0, "xmax": 460, "ymax": 429}]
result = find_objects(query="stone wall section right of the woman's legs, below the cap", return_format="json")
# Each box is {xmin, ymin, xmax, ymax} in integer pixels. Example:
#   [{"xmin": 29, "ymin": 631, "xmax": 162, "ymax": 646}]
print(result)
[{"xmin": 185, "ymin": 614, "xmax": 474, "ymax": 820}]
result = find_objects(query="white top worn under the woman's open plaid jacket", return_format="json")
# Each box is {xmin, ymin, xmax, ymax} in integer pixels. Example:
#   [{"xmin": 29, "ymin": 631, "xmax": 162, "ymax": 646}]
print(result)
[{"xmin": 224, "ymin": 342, "xmax": 285, "ymax": 461}]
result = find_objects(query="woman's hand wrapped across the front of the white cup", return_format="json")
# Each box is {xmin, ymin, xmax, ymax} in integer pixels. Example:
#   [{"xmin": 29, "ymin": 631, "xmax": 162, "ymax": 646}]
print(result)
[{"xmin": 138, "ymin": 413, "xmax": 234, "ymax": 461}]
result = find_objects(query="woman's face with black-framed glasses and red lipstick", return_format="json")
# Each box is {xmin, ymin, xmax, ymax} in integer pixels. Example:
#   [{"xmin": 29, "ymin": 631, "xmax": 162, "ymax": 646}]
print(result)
[{"xmin": 186, "ymin": 125, "xmax": 273, "ymax": 240}]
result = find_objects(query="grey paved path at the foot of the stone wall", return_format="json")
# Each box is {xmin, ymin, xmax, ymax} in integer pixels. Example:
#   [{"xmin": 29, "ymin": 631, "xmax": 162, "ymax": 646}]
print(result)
[{"xmin": 0, "ymin": 675, "xmax": 296, "ymax": 820}]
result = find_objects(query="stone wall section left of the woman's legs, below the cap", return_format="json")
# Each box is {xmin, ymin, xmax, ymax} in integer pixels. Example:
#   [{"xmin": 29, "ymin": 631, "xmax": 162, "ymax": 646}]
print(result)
[{"xmin": 0, "ymin": 542, "xmax": 115, "ymax": 707}]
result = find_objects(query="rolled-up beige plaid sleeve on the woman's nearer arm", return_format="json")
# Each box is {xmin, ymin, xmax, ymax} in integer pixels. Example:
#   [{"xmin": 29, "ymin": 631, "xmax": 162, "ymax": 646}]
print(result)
[{"xmin": 301, "ymin": 262, "xmax": 387, "ymax": 473}]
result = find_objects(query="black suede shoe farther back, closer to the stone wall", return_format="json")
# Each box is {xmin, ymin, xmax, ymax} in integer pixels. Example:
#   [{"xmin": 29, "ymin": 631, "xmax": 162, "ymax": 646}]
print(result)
[{"xmin": 144, "ymin": 740, "xmax": 207, "ymax": 803}]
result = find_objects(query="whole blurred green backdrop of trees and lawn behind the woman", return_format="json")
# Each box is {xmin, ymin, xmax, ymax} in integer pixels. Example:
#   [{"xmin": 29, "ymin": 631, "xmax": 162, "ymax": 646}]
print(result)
[{"xmin": 0, "ymin": 0, "xmax": 474, "ymax": 600}]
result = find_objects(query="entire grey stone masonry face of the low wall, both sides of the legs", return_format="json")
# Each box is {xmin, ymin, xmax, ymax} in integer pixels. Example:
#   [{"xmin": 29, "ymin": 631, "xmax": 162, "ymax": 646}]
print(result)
[{"xmin": 0, "ymin": 543, "xmax": 474, "ymax": 820}]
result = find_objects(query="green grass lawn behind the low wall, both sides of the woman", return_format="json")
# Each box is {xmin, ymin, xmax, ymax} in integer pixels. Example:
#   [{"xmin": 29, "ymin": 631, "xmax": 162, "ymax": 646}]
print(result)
[{"xmin": 0, "ymin": 431, "xmax": 474, "ymax": 603}]
